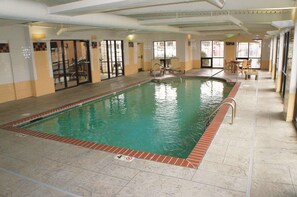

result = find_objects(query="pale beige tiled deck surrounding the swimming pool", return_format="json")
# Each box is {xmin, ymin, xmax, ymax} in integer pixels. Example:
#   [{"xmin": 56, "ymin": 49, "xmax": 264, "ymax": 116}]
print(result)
[{"xmin": 0, "ymin": 70, "xmax": 297, "ymax": 197}]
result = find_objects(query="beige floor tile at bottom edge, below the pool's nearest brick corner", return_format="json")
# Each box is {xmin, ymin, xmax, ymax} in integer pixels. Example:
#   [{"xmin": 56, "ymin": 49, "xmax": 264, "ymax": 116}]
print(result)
[{"xmin": 117, "ymin": 172, "xmax": 244, "ymax": 197}]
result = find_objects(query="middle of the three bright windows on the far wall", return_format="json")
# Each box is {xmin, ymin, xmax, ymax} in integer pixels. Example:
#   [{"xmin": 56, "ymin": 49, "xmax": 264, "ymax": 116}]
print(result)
[{"xmin": 201, "ymin": 41, "xmax": 224, "ymax": 68}]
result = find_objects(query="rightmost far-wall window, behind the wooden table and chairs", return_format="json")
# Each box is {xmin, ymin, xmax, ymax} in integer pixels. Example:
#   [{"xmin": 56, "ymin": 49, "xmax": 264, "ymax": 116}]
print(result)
[{"xmin": 236, "ymin": 40, "xmax": 262, "ymax": 69}]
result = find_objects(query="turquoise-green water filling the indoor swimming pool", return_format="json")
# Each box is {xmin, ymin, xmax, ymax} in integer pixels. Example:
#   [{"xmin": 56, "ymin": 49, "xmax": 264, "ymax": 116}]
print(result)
[{"xmin": 22, "ymin": 78, "xmax": 233, "ymax": 158}]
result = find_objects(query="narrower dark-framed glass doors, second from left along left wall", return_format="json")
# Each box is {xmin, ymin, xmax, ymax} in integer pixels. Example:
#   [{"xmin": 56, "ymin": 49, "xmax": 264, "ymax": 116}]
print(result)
[{"xmin": 100, "ymin": 40, "xmax": 125, "ymax": 80}]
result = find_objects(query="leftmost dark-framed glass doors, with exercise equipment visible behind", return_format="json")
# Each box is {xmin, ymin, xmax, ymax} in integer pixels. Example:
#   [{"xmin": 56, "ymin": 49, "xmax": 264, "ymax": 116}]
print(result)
[{"xmin": 51, "ymin": 40, "xmax": 91, "ymax": 90}]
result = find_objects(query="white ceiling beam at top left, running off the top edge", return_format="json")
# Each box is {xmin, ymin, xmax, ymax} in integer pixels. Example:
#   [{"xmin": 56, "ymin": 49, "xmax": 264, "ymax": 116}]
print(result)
[{"xmin": 48, "ymin": 0, "xmax": 125, "ymax": 14}]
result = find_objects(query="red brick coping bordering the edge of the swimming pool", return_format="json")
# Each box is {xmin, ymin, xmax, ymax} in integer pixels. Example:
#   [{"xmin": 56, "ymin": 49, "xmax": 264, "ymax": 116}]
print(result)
[{"xmin": 0, "ymin": 77, "xmax": 240, "ymax": 168}]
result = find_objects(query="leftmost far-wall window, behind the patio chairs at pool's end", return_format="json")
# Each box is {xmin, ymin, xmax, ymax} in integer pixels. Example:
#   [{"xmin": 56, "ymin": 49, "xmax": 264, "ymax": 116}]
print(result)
[{"xmin": 154, "ymin": 41, "xmax": 176, "ymax": 66}]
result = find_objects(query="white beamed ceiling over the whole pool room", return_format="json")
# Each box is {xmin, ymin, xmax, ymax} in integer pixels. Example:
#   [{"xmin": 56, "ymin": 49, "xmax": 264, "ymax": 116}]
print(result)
[{"xmin": 0, "ymin": 0, "xmax": 296, "ymax": 35}]
